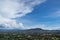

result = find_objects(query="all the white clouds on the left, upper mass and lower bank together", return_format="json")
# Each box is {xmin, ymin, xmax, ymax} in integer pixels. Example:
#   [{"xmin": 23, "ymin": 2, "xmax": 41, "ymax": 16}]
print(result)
[{"xmin": 0, "ymin": 0, "xmax": 46, "ymax": 28}]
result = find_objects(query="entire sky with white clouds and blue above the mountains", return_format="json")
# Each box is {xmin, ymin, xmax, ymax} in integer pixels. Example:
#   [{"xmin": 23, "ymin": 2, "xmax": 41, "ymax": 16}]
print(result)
[{"xmin": 0, "ymin": 0, "xmax": 60, "ymax": 30}]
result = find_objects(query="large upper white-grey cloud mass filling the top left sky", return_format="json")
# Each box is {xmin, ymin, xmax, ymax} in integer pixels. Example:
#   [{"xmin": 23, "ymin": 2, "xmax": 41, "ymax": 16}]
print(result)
[{"xmin": 0, "ymin": 0, "xmax": 45, "ymax": 18}]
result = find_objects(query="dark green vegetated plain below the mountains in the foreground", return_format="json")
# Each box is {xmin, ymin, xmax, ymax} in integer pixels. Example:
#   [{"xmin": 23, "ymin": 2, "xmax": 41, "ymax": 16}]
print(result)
[{"xmin": 0, "ymin": 32, "xmax": 60, "ymax": 40}]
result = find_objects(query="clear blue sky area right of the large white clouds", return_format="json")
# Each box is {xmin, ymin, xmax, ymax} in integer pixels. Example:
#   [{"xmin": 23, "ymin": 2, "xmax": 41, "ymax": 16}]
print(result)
[{"xmin": 18, "ymin": 0, "xmax": 60, "ymax": 29}]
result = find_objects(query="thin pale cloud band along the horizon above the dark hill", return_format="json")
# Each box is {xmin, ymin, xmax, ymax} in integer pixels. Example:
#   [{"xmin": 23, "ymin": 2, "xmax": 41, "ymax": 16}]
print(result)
[{"xmin": 26, "ymin": 24, "xmax": 60, "ymax": 30}]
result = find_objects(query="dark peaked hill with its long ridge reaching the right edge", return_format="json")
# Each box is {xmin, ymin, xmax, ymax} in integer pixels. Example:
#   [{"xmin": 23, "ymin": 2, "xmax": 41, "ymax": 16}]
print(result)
[{"xmin": 22, "ymin": 28, "xmax": 60, "ymax": 34}]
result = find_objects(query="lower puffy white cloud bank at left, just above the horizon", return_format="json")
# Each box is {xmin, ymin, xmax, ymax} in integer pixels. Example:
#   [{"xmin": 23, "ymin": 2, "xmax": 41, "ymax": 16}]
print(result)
[{"xmin": 0, "ymin": 17, "xmax": 24, "ymax": 29}]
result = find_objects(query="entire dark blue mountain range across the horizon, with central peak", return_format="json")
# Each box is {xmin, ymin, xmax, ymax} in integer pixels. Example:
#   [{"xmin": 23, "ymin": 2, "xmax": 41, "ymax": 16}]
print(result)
[{"xmin": 0, "ymin": 28, "xmax": 60, "ymax": 34}]
